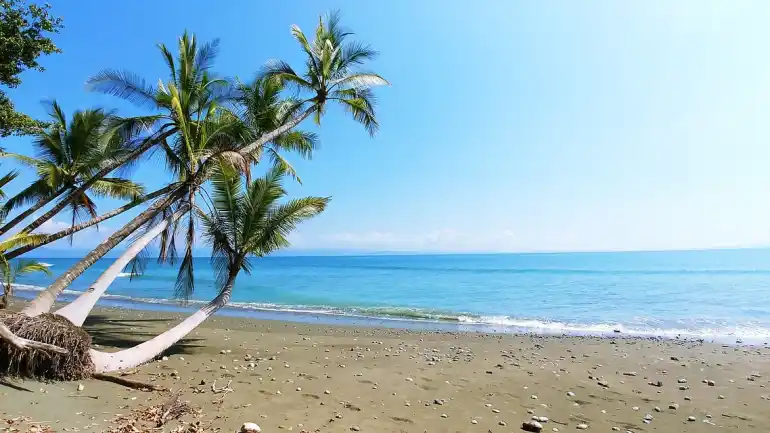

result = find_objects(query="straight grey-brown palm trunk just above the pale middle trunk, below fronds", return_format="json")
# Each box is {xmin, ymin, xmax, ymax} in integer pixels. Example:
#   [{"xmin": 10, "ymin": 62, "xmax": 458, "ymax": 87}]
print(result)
[{"xmin": 22, "ymin": 188, "xmax": 184, "ymax": 317}]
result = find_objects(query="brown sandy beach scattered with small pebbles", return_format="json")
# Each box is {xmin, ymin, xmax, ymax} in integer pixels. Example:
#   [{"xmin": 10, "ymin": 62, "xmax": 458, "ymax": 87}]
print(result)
[{"xmin": 0, "ymin": 309, "xmax": 770, "ymax": 433}]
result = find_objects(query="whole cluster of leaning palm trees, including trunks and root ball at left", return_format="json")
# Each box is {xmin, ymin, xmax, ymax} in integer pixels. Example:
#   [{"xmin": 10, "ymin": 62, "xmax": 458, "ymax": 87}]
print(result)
[{"xmin": 0, "ymin": 12, "xmax": 388, "ymax": 380}]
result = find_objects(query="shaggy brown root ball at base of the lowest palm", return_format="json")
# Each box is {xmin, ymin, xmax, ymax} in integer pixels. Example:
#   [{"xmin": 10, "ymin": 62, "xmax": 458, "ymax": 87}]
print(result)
[{"xmin": 0, "ymin": 311, "xmax": 94, "ymax": 380}]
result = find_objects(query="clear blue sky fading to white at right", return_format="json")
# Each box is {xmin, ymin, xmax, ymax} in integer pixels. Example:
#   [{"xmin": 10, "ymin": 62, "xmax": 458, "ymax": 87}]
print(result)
[{"xmin": 3, "ymin": 0, "xmax": 770, "ymax": 255}]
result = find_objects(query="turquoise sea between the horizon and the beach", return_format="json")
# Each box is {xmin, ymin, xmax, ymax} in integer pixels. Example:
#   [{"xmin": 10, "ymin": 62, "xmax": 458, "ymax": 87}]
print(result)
[{"xmin": 13, "ymin": 250, "xmax": 770, "ymax": 341}]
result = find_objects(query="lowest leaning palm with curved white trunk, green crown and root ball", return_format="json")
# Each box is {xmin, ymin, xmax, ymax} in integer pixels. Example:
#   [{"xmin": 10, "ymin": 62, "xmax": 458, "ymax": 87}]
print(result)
[{"xmin": 0, "ymin": 163, "xmax": 329, "ymax": 379}]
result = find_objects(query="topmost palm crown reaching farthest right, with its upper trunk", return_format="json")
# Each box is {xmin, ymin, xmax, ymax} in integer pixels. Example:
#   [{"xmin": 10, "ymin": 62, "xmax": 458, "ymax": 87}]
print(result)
[{"xmin": 236, "ymin": 12, "xmax": 389, "ymax": 157}]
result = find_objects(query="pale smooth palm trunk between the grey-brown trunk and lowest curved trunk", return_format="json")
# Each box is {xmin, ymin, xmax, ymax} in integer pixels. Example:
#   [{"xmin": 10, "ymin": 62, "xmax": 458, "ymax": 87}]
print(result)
[{"xmin": 56, "ymin": 206, "xmax": 188, "ymax": 326}]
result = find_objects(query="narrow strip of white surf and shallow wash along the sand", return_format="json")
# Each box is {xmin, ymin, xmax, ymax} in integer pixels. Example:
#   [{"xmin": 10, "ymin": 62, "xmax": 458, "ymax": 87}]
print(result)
[{"xmin": 15, "ymin": 285, "xmax": 770, "ymax": 346}]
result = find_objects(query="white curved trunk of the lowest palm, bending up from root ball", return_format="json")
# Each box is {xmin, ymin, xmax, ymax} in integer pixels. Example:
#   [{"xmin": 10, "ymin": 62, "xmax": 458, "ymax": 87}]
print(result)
[{"xmin": 91, "ymin": 269, "xmax": 238, "ymax": 373}]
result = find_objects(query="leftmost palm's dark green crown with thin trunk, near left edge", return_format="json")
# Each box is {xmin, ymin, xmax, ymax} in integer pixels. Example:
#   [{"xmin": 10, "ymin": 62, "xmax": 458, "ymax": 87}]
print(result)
[{"xmin": 0, "ymin": 101, "xmax": 143, "ymax": 234}]
